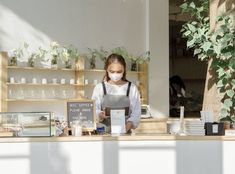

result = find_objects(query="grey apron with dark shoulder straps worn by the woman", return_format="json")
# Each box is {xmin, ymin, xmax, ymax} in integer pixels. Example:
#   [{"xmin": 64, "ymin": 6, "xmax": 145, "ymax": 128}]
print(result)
[{"xmin": 101, "ymin": 82, "xmax": 131, "ymax": 132}]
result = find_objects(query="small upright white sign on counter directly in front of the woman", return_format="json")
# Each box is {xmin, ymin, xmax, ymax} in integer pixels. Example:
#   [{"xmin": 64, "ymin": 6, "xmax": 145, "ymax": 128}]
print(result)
[{"xmin": 110, "ymin": 110, "xmax": 126, "ymax": 134}]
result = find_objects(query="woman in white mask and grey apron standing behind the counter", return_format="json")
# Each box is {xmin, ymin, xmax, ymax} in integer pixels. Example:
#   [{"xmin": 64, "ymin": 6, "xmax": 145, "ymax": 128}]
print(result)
[{"xmin": 92, "ymin": 54, "xmax": 141, "ymax": 132}]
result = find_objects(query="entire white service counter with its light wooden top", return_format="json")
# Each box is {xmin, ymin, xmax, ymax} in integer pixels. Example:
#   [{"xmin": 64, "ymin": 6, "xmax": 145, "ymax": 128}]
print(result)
[{"xmin": 0, "ymin": 134, "xmax": 235, "ymax": 174}]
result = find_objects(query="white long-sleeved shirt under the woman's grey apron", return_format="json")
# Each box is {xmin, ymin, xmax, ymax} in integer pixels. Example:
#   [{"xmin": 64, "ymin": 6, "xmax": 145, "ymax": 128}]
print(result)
[{"xmin": 91, "ymin": 82, "xmax": 141, "ymax": 128}]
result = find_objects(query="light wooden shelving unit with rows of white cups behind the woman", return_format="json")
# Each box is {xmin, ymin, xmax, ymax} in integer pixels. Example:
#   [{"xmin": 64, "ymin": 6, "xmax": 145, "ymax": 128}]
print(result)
[{"xmin": 0, "ymin": 52, "xmax": 148, "ymax": 112}]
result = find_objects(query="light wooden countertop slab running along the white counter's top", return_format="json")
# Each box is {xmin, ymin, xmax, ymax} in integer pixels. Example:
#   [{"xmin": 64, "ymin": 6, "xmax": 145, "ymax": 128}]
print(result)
[{"xmin": 0, "ymin": 134, "xmax": 235, "ymax": 143}]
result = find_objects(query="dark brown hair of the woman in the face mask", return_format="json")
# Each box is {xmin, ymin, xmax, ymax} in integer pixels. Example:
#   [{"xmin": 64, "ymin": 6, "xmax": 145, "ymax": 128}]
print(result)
[{"xmin": 103, "ymin": 54, "xmax": 128, "ymax": 81}]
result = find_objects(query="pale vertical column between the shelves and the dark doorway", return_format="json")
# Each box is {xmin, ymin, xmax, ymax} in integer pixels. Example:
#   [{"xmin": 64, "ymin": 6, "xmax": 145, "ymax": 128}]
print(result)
[{"xmin": 146, "ymin": 0, "xmax": 169, "ymax": 117}]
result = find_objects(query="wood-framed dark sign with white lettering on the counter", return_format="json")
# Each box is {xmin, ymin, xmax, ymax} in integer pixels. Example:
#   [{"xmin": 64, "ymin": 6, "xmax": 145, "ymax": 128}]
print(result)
[{"xmin": 67, "ymin": 100, "xmax": 96, "ymax": 131}]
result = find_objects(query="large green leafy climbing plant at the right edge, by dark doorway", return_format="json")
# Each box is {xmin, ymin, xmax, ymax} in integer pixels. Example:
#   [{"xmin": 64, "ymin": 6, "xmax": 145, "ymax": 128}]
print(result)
[{"xmin": 181, "ymin": 0, "xmax": 235, "ymax": 121}]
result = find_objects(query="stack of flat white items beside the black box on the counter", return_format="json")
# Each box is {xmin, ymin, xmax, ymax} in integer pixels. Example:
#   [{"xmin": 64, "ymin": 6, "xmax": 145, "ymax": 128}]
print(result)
[{"xmin": 185, "ymin": 120, "xmax": 205, "ymax": 135}]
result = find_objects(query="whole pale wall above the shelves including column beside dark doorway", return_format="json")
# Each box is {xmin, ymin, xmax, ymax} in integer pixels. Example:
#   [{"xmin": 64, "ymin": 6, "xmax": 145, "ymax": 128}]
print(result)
[{"xmin": 0, "ymin": 0, "xmax": 169, "ymax": 117}]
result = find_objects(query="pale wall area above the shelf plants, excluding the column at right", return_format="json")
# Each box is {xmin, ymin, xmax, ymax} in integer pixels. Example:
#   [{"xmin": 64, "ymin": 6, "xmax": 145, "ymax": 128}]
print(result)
[{"xmin": 0, "ymin": 0, "xmax": 145, "ymax": 53}]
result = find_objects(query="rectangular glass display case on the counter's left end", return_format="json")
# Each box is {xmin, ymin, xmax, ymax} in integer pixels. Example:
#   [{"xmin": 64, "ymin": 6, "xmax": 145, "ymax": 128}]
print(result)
[{"xmin": 0, "ymin": 112, "xmax": 55, "ymax": 137}]
